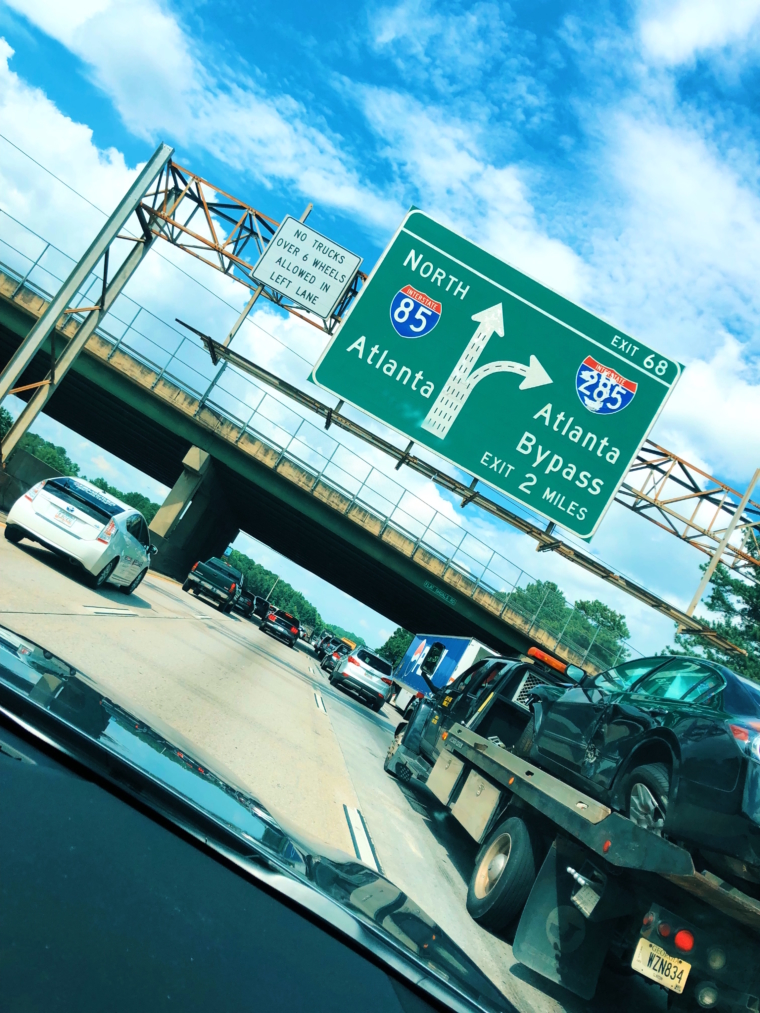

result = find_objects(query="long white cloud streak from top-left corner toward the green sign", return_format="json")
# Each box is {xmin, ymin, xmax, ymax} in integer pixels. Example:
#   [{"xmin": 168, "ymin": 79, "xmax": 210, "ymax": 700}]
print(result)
[{"xmin": 2, "ymin": 0, "xmax": 399, "ymax": 227}]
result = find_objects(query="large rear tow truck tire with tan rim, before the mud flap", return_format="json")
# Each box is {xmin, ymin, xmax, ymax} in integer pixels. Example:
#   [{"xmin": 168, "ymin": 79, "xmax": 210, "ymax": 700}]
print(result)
[{"xmin": 467, "ymin": 816, "xmax": 539, "ymax": 931}]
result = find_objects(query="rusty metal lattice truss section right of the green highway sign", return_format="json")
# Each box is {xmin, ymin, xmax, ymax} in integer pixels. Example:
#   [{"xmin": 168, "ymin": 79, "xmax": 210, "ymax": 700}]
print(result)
[{"xmin": 615, "ymin": 440, "xmax": 760, "ymax": 582}]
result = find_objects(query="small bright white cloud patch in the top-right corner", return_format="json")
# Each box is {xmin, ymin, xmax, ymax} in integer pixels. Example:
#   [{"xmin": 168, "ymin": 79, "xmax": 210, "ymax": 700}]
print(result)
[{"xmin": 640, "ymin": 0, "xmax": 760, "ymax": 66}]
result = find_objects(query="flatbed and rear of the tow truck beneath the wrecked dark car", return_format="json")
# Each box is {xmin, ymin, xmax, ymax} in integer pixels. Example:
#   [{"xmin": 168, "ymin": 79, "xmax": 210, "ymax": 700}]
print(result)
[{"xmin": 427, "ymin": 723, "xmax": 760, "ymax": 1013}]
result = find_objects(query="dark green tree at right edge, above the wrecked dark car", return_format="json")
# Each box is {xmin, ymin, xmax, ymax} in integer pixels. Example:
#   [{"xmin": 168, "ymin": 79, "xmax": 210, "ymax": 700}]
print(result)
[{"xmin": 667, "ymin": 563, "xmax": 760, "ymax": 682}]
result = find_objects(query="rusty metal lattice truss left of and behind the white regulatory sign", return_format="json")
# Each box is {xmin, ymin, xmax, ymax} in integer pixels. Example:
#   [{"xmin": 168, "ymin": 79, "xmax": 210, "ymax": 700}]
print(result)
[{"xmin": 142, "ymin": 161, "xmax": 367, "ymax": 334}]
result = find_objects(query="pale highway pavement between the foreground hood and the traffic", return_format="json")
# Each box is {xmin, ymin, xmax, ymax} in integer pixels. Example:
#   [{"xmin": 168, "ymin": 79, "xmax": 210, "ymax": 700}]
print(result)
[{"xmin": 0, "ymin": 524, "xmax": 666, "ymax": 1013}]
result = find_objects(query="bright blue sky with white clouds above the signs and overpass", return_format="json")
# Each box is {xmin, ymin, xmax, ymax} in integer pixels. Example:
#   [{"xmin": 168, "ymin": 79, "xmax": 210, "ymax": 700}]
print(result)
[{"xmin": 0, "ymin": 0, "xmax": 760, "ymax": 647}]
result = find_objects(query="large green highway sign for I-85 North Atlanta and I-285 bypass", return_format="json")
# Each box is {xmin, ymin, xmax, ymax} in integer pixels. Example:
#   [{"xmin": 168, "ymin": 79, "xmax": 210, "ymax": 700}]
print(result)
[{"xmin": 312, "ymin": 209, "xmax": 681, "ymax": 538}]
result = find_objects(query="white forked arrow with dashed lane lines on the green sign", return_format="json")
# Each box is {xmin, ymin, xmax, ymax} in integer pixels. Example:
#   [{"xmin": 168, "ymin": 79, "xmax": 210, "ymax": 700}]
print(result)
[{"xmin": 423, "ymin": 303, "xmax": 552, "ymax": 440}]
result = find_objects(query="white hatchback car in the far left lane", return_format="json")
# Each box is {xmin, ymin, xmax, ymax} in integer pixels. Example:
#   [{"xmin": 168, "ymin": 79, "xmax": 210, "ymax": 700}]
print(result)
[{"xmin": 5, "ymin": 477, "xmax": 157, "ymax": 595}]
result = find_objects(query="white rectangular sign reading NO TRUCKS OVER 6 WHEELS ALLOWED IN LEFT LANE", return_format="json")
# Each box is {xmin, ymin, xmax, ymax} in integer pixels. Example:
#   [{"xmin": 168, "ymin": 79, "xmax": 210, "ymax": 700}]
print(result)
[{"xmin": 253, "ymin": 215, "xmax": 362, "ymax": 320}]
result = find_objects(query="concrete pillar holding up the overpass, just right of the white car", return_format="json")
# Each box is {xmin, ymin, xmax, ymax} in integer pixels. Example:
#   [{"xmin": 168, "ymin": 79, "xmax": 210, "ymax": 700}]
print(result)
[{"xmin": 150, "ymin": 447, "xmax": 239, "ymax": 580}]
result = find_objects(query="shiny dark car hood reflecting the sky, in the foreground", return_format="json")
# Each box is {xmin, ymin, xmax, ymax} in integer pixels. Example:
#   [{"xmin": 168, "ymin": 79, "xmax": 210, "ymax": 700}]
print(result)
[{"xmin": 0, "ymin": 627, "xmax": 514, "ymax": 1011}]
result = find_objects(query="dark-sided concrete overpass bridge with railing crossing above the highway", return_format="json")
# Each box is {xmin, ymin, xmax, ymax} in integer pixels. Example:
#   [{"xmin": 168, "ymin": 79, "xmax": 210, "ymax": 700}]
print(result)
[{"xmin": 0, "ymin": 252, "xmax": 615, "ymax": 669}]
